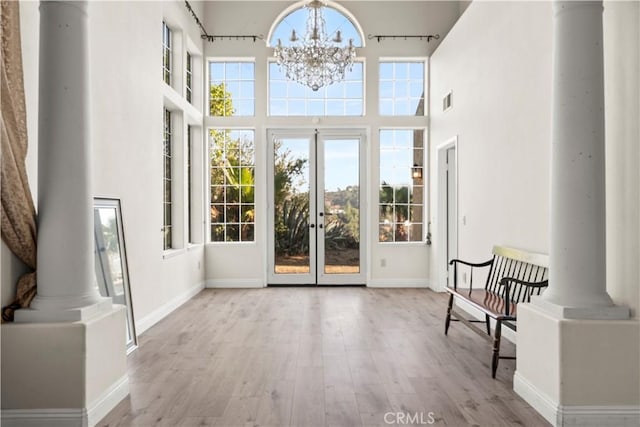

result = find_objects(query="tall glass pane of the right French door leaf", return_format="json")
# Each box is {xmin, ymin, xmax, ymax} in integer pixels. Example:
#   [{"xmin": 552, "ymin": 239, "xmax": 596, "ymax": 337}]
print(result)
[{"xmin": 324, "ymin": 139, "xmax": 360, "ymax": 274}]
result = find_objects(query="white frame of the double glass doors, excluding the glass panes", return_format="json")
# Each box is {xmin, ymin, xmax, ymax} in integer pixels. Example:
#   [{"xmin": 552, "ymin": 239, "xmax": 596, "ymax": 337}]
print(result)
[{"xmin": 265, "ymin": 126, "xmax": 369, "ymax": 286}]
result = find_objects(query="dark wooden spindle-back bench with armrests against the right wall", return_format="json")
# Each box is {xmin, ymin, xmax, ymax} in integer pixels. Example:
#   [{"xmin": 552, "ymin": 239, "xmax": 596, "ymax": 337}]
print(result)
[{"xmin": 444, "ymin": 246, "xmax": 549, "ymax": 378}]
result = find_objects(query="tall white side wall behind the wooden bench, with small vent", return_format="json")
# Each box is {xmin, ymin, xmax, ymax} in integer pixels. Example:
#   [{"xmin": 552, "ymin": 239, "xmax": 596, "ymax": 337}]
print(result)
[{"xmin": 431, "ymin": 2, "xmax": 551, "ymax": 272}]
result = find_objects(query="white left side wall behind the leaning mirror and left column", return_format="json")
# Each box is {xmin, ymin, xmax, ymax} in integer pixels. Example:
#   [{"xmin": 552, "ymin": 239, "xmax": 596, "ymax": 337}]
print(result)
[{"xmin": 2, "ymin": 1, "xmax": 204, "ymax": 332}]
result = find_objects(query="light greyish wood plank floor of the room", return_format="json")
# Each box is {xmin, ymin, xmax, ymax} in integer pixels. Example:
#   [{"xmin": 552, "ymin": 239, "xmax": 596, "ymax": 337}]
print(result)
[{"xmin": 98, "ymin": 288, "xmax": 548, "ymax": 427}]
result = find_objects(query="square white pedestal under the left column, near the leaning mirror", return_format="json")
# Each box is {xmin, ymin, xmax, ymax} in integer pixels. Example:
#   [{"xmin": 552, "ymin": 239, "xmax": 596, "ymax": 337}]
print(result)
[{"xmin": 1, "ymin": 305, "xmax": 129, "ymax": 427}]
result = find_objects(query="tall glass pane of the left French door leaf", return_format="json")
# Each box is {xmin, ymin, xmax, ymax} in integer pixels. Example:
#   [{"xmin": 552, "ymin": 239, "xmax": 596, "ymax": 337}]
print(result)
[{"xmin": 273, "ymin": 138, "xmax": 311, "ymax": 274}]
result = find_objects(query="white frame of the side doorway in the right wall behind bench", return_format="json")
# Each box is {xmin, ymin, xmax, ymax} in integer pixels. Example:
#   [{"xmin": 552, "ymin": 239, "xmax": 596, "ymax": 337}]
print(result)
[{"xmin": 436, "ymin": 135, "xmax": 459, "ymax": 291}]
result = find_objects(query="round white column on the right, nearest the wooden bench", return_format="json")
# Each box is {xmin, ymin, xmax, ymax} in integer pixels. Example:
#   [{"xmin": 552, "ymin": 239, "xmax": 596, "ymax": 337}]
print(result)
[{"xmin": 537, "ymin": 1, "xmax": 629, "ymax": 319}]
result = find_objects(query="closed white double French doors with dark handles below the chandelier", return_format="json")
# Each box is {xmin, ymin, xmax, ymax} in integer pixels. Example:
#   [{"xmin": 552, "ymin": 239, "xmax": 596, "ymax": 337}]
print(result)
[{"xmin": 267, "ymin": 129, "xmax": 366, "ymax": 285}]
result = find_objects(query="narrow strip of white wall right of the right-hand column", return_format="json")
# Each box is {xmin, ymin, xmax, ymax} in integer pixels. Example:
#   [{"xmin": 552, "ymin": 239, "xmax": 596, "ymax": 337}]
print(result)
[{"xmin": 604, "ymin": 1, "xmax": 640, "ymax": 317}]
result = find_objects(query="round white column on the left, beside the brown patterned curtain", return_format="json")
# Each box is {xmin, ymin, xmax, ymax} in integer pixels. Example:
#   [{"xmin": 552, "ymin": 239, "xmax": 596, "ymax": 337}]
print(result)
[{"xmin": 16, "ymin": 1, "xmax": 111, "ymax": 322}]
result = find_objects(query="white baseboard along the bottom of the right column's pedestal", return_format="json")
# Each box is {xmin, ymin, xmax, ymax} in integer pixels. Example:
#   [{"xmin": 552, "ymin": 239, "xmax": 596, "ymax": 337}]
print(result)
[{"xmin": 513, "ymin": 371, "xmax": 640, "ymax": 427}]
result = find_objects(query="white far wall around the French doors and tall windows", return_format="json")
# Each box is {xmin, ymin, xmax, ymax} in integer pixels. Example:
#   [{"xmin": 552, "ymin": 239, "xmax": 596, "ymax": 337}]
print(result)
[{"xmin": 204, "ymin": 1, "xmax": 459, "ymax": 286}]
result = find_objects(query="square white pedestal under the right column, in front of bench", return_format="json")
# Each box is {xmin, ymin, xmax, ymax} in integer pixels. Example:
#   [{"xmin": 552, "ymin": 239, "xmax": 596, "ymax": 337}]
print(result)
[{"xmin": 514, "ymin": 303, "xmax": 640, "ymax": 427}]
